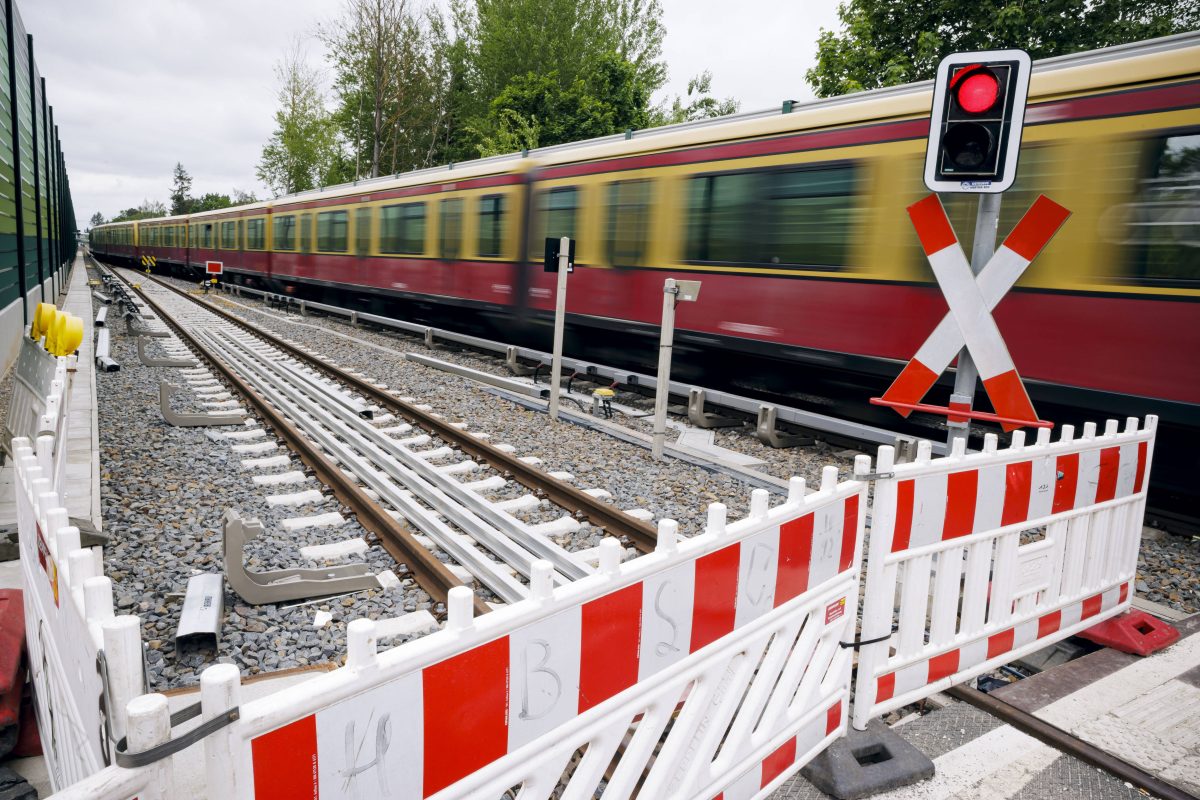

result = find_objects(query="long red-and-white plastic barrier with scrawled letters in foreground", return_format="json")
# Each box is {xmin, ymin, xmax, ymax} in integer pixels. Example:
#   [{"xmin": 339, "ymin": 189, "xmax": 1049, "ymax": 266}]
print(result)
[{"xmin": 49, "ymin": 457, "xmax": 870, "ymax": 800}]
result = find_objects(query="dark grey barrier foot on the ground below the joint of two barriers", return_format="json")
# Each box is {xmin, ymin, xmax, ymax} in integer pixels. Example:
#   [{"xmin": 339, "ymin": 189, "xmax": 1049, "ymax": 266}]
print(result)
[{"xmin": 800, "ymin": 720, "xmax": 934, "ymax": 800}]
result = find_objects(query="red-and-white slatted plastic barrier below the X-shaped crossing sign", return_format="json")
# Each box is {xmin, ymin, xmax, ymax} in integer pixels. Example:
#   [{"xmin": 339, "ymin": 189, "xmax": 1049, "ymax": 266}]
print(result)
[{"xmin": 853, "ymin": 416, "xmax": 1157, "ymax": 729}]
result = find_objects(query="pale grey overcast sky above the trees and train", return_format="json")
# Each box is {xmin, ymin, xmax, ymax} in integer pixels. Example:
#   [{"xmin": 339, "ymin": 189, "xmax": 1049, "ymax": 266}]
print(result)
[{"xmin": 16, "ymin": 0, "xmax": 836, "ymax": 224}]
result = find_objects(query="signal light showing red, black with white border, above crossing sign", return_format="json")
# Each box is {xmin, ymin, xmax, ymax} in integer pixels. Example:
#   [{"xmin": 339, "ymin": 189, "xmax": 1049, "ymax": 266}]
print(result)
[{"xmin": 925, "ymin": 50, "xmax": 1030, "ymax": 193}]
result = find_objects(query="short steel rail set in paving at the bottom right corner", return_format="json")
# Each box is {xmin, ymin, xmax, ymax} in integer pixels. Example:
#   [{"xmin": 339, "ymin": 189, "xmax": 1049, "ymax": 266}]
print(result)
[{"xmin": 946, "ymin": 686, "xmax": 1196, "ymax": 800}]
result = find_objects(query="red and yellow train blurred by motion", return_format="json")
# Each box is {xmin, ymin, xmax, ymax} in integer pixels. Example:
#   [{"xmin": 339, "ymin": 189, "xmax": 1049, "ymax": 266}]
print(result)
[{"xmin": 91, "ymin": 34, "xmax": 1200, "ymax": 527}]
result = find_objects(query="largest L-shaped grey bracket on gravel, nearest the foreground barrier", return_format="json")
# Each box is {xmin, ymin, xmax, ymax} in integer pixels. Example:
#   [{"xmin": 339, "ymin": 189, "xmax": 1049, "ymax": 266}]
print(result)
[{"xmin": 222, "ymin": 509, "xmax": 379, "ymax": 606}]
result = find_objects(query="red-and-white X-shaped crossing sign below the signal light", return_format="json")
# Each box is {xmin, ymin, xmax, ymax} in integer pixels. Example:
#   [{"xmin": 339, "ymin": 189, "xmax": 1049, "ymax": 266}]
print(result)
[{"xmin": 880, "ymin": 194, "xmax": 1070, "ymax": 431}]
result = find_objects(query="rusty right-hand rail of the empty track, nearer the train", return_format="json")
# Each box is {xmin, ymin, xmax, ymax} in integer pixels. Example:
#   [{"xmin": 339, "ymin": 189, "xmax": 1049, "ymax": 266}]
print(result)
[{"xmin": 150, "ymin": 276, "xmax": 658, "ymax": 553}]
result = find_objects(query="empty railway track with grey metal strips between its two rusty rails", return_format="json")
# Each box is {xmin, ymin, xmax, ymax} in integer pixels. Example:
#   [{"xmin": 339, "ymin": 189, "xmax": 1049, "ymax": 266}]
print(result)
[{"xmin": 97, "ymin": 262, "xmax": 655, "ymax": 612}]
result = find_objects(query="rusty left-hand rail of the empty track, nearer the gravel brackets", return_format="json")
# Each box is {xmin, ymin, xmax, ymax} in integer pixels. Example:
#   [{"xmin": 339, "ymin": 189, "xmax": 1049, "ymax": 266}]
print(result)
[{"xmin": 114, "ymin": 266, "xmax": 491, "ymax": 614}]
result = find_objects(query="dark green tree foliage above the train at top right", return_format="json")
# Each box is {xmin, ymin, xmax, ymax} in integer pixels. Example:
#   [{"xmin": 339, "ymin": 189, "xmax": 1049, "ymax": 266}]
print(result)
[{"xmin": 805, "ymin": 0, "xmax": 1200, "ymax": 97}]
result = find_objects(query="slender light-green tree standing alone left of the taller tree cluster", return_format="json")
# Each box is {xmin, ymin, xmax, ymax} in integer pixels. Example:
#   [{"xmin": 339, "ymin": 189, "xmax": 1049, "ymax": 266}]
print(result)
[{"xmin": 255, "ymin": 40, "xmax": 340, "ymax": 196}]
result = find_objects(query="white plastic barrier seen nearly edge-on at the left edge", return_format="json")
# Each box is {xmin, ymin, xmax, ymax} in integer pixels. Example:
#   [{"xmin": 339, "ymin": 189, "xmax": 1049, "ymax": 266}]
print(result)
[{"xmin": 12, "ymin": 438, "xmax": 145, "ymax": 789}]
